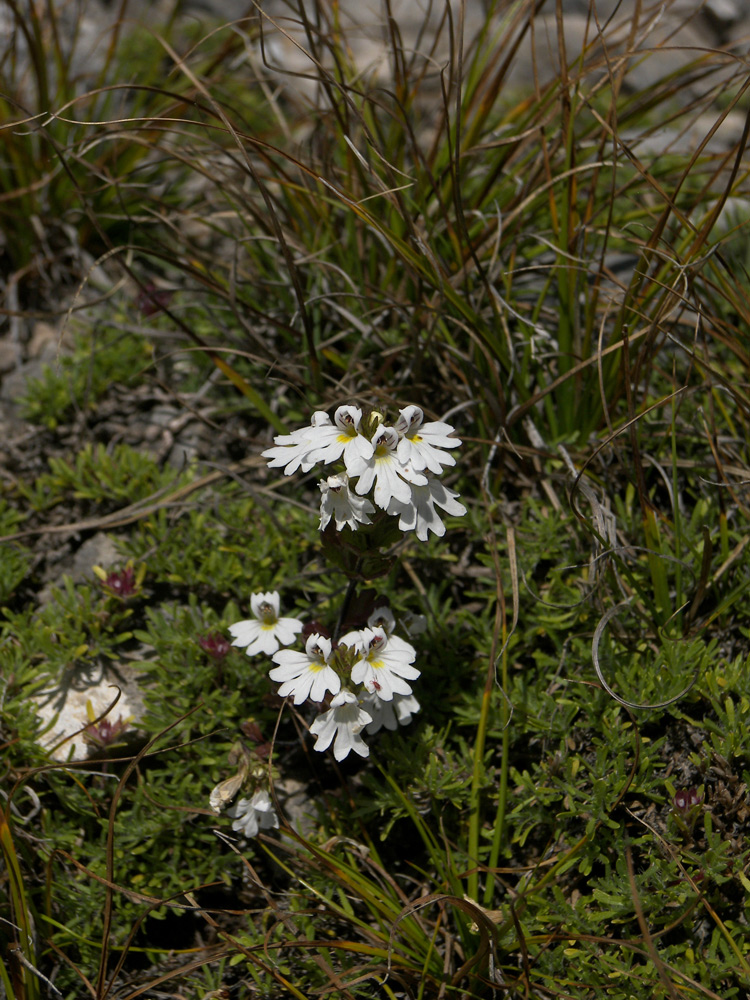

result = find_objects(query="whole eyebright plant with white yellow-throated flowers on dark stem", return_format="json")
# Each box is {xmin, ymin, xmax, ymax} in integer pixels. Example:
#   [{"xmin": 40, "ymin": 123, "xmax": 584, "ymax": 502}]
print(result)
[{"xmin": 210, "ymin": 405, "xmax": 466, "ymax": 837}]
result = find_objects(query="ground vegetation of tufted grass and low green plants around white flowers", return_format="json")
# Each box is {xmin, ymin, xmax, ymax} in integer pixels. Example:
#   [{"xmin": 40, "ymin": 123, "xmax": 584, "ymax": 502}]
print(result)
[{"xmin": 0, "ymin": 3, "xmax": 750, "ymax": 1000}]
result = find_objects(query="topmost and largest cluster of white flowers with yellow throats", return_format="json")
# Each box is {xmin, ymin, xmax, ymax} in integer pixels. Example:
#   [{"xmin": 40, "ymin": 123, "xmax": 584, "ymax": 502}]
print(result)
[{"xmin": 263, "ymin": 406, "xmax": 466, "ymax": 541}]
